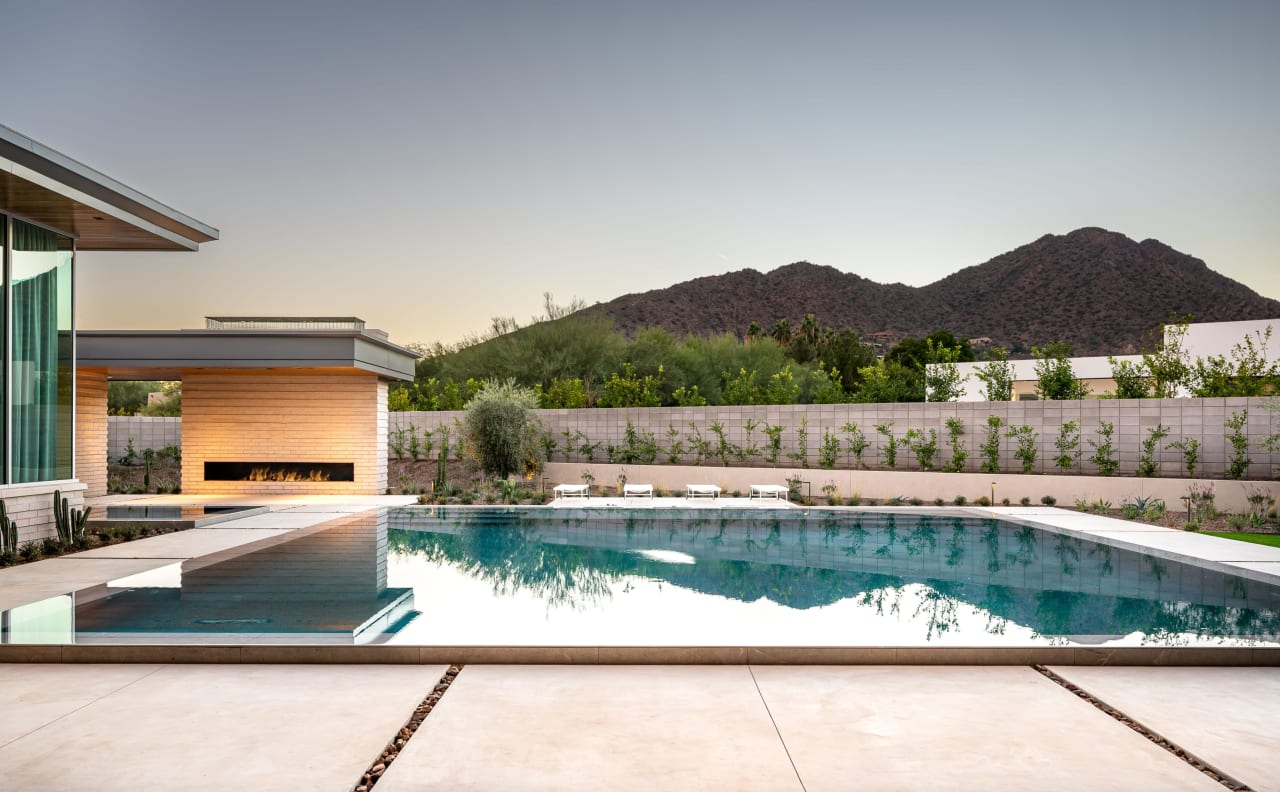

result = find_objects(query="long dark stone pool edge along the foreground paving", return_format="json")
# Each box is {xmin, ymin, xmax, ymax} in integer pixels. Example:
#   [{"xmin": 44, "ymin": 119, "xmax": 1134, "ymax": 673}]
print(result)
[{"xmin": 0, "ymin": 644, "xmax": 1280, "ymax": 667}]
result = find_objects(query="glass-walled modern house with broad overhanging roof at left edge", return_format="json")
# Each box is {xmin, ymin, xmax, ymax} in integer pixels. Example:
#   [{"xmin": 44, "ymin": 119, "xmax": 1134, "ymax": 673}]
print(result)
[{"xmin": 0, "ymin": 127, "xmax": 218, "ymax": 541}]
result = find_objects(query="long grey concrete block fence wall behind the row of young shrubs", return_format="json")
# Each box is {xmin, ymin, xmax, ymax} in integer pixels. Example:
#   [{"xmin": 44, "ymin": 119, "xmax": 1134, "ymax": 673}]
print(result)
[{"xmin": 109, "ymin": 398, "xmax": 1280, "ymax": 480}]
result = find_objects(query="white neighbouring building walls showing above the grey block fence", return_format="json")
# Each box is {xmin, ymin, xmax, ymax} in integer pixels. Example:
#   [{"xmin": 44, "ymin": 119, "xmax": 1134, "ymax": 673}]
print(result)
[{"xmin": 936, "ymin": 319, "xmax": 1280, "ymax": 402}]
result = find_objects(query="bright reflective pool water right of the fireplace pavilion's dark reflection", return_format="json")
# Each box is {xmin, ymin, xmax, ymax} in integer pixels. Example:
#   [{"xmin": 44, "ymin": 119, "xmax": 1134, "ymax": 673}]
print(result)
[{"xmin": 388, "ymin": 509, "xmax": 1280, "ymax": 646}]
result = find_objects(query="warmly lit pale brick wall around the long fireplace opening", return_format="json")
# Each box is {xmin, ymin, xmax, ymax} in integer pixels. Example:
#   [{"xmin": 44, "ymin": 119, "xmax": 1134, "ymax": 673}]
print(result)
[{"xmin": 182, "ymin": 370, "xmax": 387, "ymax": 495}]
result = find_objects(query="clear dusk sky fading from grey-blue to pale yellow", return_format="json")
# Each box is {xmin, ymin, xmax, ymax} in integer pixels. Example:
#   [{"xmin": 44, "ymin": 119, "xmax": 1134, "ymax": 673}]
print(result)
[{"xmin": 0, "ymin": 0, "xmax": 1280, "ymax": 343}]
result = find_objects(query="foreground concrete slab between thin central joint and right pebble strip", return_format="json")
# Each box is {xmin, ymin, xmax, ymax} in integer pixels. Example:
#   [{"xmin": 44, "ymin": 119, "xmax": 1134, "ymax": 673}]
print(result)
[{"xmin": 751, "ymin": 667, "xmax": 1222, "ymax": 792}]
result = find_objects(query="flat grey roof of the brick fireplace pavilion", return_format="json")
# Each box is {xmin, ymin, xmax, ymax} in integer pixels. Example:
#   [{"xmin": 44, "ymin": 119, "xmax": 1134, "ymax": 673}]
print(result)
[{"xmin": 76, "ymin": 330, "xmax": 417, "ymax": 381}]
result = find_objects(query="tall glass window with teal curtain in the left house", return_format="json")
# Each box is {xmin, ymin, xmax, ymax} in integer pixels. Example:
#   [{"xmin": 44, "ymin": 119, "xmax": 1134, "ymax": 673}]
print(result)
[{"xmin": 9, "ymin": 220, "xmax": 74, "ymax": 484}]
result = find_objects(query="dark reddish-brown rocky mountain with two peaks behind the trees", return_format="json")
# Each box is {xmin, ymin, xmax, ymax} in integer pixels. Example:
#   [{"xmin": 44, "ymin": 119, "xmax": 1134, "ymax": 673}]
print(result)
[{"xmin": 590, "ymin": 228, "xmax": 1280, "ymax": 356}]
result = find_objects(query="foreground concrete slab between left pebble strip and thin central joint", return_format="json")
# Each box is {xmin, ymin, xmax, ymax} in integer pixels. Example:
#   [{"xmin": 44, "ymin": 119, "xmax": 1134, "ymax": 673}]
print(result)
[{"xmin": 376, "ymin": 665, "xmax": 801, "ymax": 792}]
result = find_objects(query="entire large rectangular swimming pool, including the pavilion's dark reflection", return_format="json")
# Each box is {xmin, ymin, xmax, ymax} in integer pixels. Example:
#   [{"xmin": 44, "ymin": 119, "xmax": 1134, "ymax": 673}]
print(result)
[{"xmin": 5, "ymin": 508, "xmax": 1280, "ymax": 646}]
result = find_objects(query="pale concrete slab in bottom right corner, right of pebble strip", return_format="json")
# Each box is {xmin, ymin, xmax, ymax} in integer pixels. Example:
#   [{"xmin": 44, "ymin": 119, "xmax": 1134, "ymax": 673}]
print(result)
[{"xmin": 1052, "ymin": 665, "xmax": 1280, "ymax": 792}]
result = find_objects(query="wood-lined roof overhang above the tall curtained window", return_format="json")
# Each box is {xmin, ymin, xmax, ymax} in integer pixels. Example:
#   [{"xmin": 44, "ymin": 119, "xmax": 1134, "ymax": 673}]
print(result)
[{"xmin": 0, "ymin": 125, "xmax": 218, "ymax": 251}]
